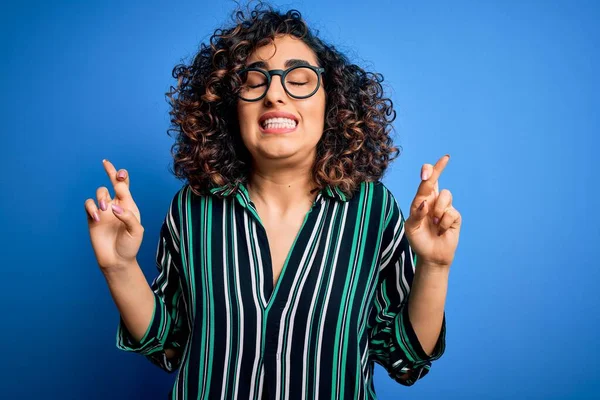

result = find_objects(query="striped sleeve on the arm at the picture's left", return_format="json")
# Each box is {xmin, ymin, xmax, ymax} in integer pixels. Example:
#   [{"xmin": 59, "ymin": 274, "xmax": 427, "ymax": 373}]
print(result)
[{"xmin": 117, "ymin": 192, "xmax": 189, "ymax": 372}]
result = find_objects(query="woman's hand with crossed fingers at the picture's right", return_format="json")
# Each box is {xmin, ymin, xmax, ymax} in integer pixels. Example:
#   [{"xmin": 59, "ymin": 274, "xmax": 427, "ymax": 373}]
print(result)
[{"xmin": 404, "ymin": 155, "xmax": 462, "ymax": 268}]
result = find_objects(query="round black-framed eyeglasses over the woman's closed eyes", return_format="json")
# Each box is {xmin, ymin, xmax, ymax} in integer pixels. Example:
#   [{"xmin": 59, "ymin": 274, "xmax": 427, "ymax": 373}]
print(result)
[{"xmin": 238, "ymin": 65, "xmax": 325, "ymax": 101}]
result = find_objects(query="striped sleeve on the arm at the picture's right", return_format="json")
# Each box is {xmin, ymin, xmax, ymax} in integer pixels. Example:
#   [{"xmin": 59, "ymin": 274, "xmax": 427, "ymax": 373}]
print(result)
[{"xmin": 369, "ymin": 188, "xmax": 446, "ymax": 386}]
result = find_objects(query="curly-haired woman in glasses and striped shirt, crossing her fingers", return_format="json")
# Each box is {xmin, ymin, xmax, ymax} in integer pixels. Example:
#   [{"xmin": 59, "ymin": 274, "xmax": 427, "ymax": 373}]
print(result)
[{"xmin": 85, "ymin": 5, "xmax": 461, "ymax": 399}]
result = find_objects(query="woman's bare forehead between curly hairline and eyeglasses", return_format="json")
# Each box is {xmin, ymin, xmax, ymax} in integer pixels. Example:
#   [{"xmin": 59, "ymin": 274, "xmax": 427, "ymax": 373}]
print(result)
[{"xmin": 246, "ymin": 35, "xmax": 317, "ymax": 67}]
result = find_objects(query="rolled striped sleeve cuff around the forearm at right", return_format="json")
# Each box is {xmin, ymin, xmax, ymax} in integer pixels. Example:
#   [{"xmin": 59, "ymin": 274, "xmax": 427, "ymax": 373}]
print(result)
[{"xmin": 392, "ymin": 303, "xmax": 446, "ymax": 367}]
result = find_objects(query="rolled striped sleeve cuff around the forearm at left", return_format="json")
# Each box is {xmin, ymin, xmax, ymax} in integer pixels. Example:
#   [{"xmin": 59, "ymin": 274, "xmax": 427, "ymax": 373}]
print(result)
[{"xmin": 117, "ymin": 293, "xmax": 170, "ymax": 355}]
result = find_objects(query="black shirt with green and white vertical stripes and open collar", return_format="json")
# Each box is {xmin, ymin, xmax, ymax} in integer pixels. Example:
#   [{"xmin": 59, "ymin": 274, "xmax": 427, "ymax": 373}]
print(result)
[{"xmin": 117, "ymin": 181, "xmax": 446, "ymax": 400}]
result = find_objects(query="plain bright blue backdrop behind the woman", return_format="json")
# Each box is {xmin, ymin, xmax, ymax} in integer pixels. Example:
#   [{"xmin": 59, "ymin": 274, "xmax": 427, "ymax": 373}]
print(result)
[{"xmin": 0, "ymin": 0, "xmax": 600, "ymax": 399}]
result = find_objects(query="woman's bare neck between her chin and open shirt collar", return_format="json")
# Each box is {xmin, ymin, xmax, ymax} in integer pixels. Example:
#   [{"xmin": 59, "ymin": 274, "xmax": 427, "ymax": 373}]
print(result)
[{"xmin": 247, "ymin": 159, "xmax": 317, "ymax": 215}]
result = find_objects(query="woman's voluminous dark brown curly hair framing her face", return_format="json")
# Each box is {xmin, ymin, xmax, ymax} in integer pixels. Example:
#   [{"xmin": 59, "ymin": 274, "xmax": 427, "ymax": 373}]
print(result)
[{"xmin": 166, "ymin": 2, "xmax": 400, "ymax": 198}]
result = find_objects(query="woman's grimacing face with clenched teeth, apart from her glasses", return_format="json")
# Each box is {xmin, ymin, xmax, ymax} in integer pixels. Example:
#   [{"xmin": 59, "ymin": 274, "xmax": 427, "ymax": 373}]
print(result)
[{"xmin": 237, "ymin": 35, "xmax": 325, "ymax": 166}]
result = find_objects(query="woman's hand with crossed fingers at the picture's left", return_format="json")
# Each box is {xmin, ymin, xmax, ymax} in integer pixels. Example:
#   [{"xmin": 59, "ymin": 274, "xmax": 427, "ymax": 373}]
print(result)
[{"xmin": 85, "ymin": 160, "xmax": 144, "ymax": 271}]
